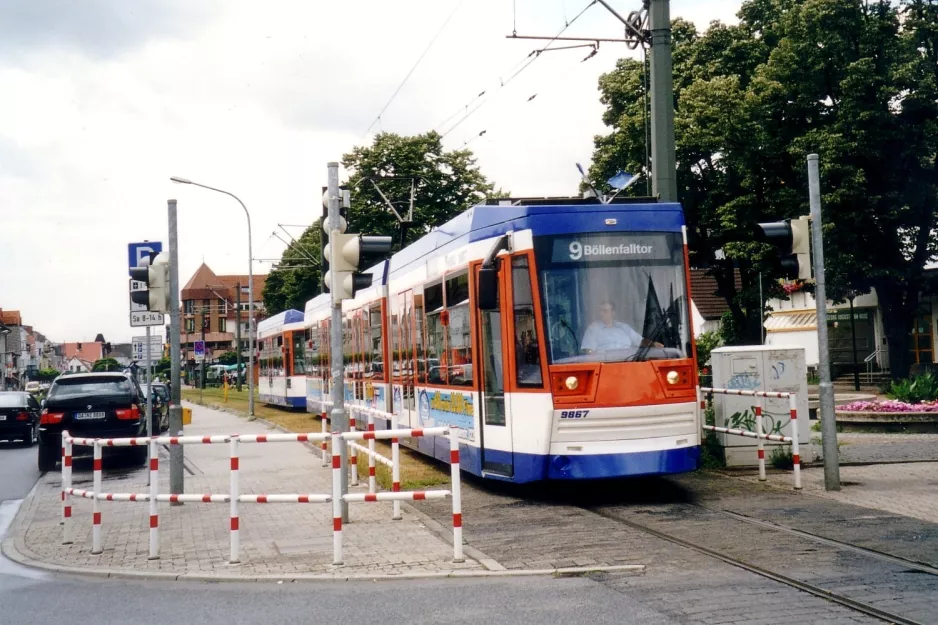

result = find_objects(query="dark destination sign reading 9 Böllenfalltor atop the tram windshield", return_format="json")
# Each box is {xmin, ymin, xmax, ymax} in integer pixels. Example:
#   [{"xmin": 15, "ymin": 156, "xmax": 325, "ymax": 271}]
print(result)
[{"xmin": 551, "ymin": 233, "xmax": 675, "ymax": 263}]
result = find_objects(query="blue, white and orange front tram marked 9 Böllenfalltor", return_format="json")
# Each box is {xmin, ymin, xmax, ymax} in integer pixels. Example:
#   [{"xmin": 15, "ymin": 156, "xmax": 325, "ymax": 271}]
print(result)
[{"xmin": 305, "ymin": 198, "xmax": 701, "ymax": 482}]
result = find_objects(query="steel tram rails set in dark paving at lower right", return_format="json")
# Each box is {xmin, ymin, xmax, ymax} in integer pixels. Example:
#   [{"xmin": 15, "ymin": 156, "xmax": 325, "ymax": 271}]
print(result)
[{"xmin": 578, "ymin": 503, "xmax": 938, "ymax": 625}]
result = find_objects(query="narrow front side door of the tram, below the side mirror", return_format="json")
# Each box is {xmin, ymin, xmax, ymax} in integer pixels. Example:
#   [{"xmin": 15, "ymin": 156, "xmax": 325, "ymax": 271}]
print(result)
[{"xmin": 474, "ymin": 262, "xmax": 514, "ymax": 477}]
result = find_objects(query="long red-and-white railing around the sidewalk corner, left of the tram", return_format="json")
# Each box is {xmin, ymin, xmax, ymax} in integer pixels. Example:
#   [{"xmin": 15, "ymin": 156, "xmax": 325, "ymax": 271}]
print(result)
[{"xmin": 61, "ymin": 419, "xmax": 463, "ymax": 565}]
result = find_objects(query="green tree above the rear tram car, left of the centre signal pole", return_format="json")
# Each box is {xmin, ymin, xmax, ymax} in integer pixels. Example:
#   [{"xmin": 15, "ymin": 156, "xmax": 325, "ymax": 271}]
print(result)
[{"xmin": 262, "ymin": 220, "xmax": 321, "ymax": 315}]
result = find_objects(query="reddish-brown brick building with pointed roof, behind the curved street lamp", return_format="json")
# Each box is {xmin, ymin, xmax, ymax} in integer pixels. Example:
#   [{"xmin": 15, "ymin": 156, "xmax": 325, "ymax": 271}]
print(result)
[{"xmin": 180, "ymin": 263, "xmax": 267, "ymax": 361}]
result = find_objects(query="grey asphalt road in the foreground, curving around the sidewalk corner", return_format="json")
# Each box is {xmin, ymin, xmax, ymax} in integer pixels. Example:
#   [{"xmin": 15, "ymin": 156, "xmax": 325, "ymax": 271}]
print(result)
[{"xmin": 0, "ymin": 444, "xmax": 676, "ymax": 625}]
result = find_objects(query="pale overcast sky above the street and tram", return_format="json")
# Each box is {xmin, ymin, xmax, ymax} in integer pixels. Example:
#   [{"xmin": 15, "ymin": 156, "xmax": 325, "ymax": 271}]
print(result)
[{"xmin": 0, "ymin": 0, "xmax": 741, "ymax": 342}]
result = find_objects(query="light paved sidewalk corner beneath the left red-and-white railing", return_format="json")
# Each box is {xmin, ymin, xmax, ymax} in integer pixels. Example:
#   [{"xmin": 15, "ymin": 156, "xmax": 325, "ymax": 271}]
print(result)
[{"xmin": 4, "ymin": 404, "xmax": 497, "ymax": 579}]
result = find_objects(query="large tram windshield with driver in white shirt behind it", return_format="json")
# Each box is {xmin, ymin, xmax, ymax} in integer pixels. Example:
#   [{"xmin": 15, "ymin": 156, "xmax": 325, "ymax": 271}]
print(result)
[{"xmin": 534, "ymin": 232, "xmax": 691, "ymax": 364}]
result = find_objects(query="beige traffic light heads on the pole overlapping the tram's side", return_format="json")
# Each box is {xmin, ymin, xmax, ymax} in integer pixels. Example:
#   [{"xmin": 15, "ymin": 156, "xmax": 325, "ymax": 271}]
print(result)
[{"xmin": 323, "ymin": 232, "xmax": 394, "ymax": 301}]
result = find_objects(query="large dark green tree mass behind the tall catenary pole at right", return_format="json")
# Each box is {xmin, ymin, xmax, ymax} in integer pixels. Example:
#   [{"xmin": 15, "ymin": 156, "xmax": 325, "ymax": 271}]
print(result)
[{"xmin": 592, "ymin": 0, "xmax": 938, "ymax": 376}]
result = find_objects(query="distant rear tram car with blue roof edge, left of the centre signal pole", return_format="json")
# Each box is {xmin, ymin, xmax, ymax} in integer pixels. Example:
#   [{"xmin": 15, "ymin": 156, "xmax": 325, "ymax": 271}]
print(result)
[{"xmin": 257, "ymin": 310, "xmax": 306, "ymax": 408}]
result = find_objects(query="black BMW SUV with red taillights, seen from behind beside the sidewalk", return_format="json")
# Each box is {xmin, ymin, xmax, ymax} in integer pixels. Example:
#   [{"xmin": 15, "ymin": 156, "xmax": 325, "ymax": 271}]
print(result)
[{"xmin": 39, "ymin": 373, "xmax": 148, "ymax": 471}]
